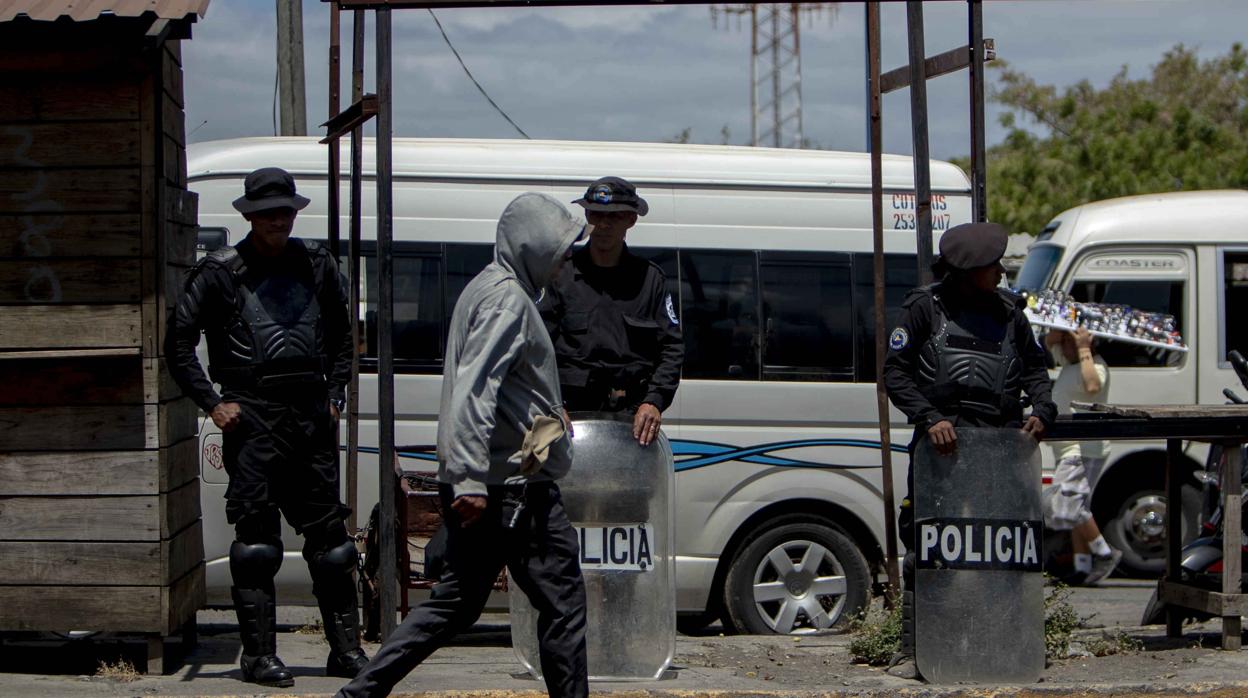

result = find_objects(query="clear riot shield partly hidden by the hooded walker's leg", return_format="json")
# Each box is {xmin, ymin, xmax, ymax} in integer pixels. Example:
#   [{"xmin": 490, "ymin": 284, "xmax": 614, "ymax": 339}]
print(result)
[{"xmin": 510, "ymin": 413, "xmax": 676, "ymax": 681}]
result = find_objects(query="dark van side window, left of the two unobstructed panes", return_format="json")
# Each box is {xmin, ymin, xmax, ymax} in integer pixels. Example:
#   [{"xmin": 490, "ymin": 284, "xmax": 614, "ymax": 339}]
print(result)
[{"xmin": 680, "ymin": 250, "xmax": 761, "ymax": 381}]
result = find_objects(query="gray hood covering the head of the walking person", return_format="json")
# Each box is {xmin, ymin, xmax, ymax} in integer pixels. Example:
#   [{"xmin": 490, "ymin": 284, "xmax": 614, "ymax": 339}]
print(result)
[{"xmin": 494, "ymin": 192, "xmax": 585, "ymax": 295}]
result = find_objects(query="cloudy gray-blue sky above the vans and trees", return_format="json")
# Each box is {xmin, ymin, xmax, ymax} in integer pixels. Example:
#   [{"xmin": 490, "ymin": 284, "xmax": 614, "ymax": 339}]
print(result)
[{"xmin": 183, "ymin": 0, "xmax": 1248, "ymax": 157}]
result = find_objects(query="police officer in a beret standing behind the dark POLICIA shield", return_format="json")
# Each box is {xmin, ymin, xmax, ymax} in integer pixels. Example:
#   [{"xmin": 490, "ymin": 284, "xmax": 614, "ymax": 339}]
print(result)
[{"xmin": 884, "ymin": 224, "xmax": 1057, "ymax": 678}]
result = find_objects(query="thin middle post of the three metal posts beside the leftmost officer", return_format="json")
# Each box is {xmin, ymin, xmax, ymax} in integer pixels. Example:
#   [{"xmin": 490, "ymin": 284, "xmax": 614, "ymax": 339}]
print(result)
[{"xmin": 347, "ymin": 10, "xmax": 364, "ymax": 533}]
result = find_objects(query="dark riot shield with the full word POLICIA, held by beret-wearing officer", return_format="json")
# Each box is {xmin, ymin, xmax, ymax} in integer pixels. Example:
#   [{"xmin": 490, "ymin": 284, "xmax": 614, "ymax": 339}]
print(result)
[{"xmin": 914, "ymin": 428, "xmax": 1045, "ymax": 683}]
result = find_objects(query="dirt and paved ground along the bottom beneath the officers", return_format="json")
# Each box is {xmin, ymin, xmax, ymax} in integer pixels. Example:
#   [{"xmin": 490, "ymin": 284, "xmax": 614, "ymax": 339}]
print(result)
[{"xmin": 0, "ymin": 581, "xmax": 1248, "ymax": 698}]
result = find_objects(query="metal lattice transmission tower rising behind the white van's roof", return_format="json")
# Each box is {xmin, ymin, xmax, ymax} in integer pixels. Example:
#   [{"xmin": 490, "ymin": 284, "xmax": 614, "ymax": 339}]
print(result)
[{"xmin": 710, "ymin": 2, "xmax": 836, "ymax": 147}]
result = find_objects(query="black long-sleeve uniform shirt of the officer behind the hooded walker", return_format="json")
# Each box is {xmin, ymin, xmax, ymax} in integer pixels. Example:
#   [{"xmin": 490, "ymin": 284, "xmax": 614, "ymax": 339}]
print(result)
[{"xmin": 542, "ymin": 246, "xmax": 685, "ymax": 411}]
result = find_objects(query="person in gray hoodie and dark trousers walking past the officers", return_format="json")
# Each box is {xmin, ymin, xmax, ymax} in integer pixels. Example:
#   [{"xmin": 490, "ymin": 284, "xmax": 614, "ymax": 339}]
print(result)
[{"xmin": 338, "ymin": 194, "xmax": 589, "ymax": 698}]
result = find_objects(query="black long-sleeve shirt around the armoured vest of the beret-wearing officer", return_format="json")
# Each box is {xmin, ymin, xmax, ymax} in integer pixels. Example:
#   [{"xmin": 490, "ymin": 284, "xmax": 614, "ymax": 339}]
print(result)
[{"xmin": 884, "ymin": 285, "xmax": 1057, "ymax": 430}]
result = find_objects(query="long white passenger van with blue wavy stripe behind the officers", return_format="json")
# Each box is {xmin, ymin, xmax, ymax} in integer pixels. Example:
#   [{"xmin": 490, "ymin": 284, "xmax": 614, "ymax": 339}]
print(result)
[{"xmin": 188, "ymin": 139, "xmax": 970, "ymax": 633}]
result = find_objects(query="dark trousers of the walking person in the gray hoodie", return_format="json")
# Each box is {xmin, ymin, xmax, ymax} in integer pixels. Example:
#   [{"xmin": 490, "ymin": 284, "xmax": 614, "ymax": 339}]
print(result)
[{"xmin": 338, "ymin": 482, "xmax": 589, "ymax": 698}]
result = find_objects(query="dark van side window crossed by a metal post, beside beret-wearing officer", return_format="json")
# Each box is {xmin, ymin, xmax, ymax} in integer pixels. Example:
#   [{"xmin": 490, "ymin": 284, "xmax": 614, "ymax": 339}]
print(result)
[{"xmin": 854, "ymin": 252, "xmax": 919, "ymax": 383}]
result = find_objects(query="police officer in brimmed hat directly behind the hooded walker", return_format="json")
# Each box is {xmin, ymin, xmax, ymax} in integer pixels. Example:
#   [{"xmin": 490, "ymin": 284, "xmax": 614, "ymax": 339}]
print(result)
[{"xmin": 542, "ymin": 177, "xmax": 685, "ymax": 446}]
